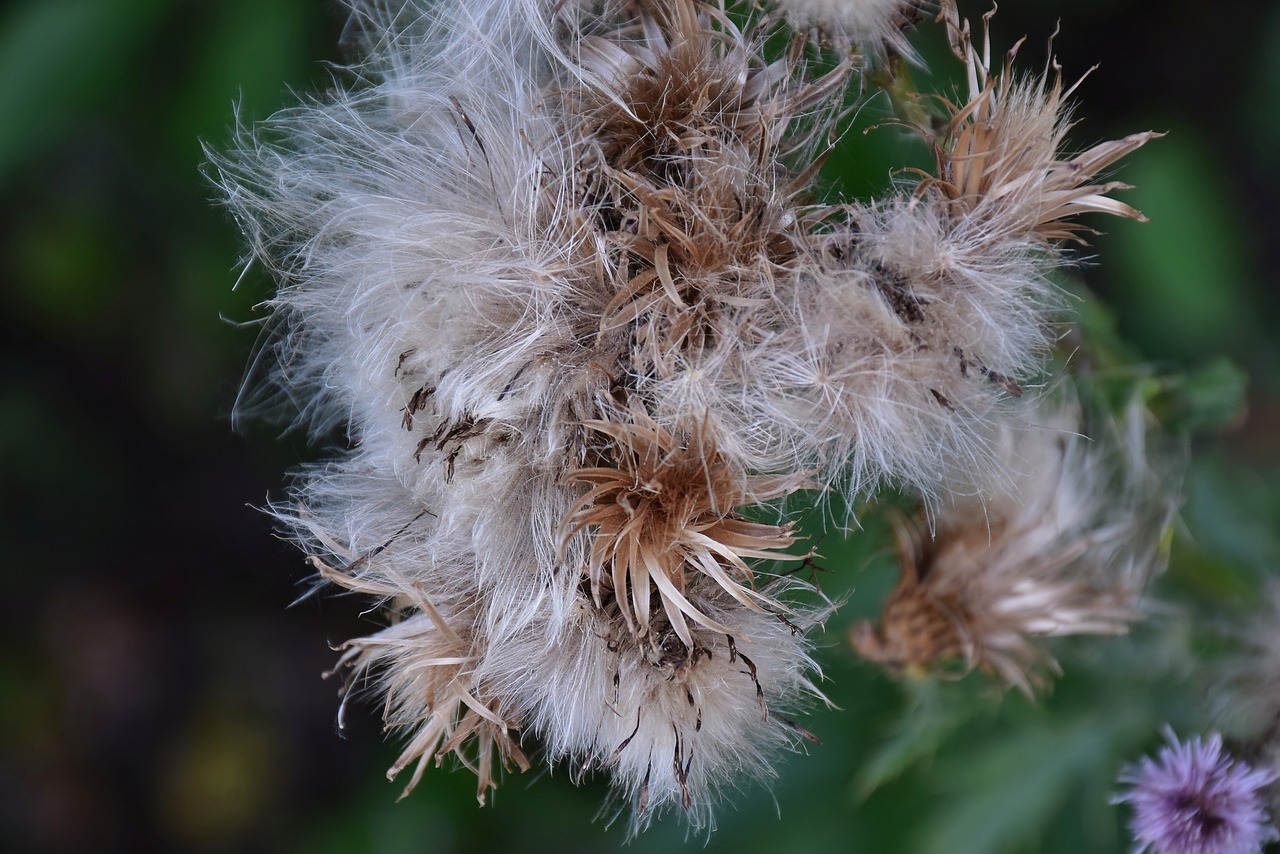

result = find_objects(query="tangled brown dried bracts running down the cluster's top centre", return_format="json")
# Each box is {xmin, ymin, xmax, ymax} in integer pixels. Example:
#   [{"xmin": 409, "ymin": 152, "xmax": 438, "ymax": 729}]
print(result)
[{"xmin": 564, "ymin": 0, "xmax": 850, "ymax": 382}]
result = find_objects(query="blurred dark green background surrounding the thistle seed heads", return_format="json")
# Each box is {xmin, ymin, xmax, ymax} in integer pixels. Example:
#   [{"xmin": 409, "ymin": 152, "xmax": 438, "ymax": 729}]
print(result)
[{"xmin": 0, "ymin": 0, "xmax": 1280, "ymax": 854}]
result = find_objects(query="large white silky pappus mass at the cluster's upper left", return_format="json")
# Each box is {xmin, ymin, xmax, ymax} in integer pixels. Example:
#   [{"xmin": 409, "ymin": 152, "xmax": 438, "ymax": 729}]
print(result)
[{"xmin": 212, "ymin": 3, "xmax": 609, "ymax": 471}]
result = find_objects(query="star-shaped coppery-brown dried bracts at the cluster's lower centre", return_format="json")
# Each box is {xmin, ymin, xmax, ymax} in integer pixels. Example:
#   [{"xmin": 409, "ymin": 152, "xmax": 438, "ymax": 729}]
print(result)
[{"xmin": 564, "ymin": 412, "xmax": 809, "ymax": 649}]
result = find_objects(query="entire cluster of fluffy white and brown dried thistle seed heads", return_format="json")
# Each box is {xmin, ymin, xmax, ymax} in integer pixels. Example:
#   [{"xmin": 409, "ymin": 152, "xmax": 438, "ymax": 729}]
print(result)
[{"xmin": 211, "ymin": 0, "xmax": 1177, "ymax": 826}]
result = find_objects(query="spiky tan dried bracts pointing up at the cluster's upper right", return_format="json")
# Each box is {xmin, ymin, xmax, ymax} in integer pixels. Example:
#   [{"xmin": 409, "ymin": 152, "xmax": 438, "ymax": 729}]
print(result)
[{"xmin": 922, "ymin": 6, "xmax": 1161, "ymax": 245}]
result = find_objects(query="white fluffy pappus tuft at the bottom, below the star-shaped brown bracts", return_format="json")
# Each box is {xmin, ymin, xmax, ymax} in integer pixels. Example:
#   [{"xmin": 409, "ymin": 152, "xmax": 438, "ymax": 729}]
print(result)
[{"xmin": 484, "ymin": 579, "xmax": 829, "ymax": 832}]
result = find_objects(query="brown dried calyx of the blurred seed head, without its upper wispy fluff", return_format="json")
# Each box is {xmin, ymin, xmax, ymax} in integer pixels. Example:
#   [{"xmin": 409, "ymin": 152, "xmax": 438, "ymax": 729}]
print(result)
[{"xmin": 850, "ymin": 491, "xmax": 1138, "ymax": 697}]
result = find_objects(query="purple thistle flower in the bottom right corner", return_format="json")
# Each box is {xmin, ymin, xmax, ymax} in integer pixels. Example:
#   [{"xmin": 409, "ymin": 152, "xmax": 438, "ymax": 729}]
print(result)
[{"xmin": 1114, "ymin": 727, "xmax": 1280, "ymax": 854}]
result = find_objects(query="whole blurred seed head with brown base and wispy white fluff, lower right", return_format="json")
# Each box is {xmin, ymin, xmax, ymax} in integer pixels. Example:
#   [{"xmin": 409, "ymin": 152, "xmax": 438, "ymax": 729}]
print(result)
[{"xmin": 850, "ymin": 410, "xmax": 1178, "ymax": 697}]
